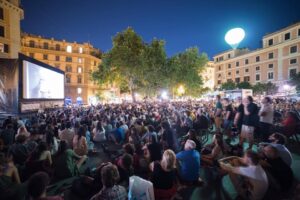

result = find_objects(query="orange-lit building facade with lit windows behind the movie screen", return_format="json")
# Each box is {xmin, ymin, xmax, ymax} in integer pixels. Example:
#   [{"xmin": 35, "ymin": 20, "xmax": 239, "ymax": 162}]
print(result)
[{"xmin": 21, "ymin": 33, "xmax": 101, "ymax": 104}]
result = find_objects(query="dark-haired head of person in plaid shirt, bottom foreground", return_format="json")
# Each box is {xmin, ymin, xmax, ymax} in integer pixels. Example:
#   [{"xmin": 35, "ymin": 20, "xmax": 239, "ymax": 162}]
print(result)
[{"xmin": 101, "ymin": 164, "xmax": 120, "ymax": 188}]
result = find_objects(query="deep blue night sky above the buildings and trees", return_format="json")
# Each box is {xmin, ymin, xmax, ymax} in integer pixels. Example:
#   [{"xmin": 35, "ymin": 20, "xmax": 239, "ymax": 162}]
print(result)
[{"xmin": 21, "ymin": 0, "xmax": 300, "ymax": 58}]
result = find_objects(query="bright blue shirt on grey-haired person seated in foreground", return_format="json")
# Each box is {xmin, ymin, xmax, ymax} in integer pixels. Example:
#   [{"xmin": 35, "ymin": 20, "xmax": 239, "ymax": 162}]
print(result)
[{"xmin": 176, "ymin": 150, "xmax": 200, "ymax": 181}]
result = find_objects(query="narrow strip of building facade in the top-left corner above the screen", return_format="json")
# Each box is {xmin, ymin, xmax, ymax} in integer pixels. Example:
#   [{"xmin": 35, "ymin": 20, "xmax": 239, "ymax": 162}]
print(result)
[{"xmin": 0, "ymin": 0, "xmax": 24, "ymax": 59}]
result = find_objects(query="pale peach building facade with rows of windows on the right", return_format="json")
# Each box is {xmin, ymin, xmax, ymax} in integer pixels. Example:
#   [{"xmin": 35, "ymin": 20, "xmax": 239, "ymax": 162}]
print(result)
[{"xmin": 214, "ymin": 22, "xmax": 300, "ymax": 90}]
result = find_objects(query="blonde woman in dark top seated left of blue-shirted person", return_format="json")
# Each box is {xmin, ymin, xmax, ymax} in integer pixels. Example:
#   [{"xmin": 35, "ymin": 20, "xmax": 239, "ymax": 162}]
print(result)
[{"xmin": 150, "ymin": 149, "xmax": 177, "ymax": 200}]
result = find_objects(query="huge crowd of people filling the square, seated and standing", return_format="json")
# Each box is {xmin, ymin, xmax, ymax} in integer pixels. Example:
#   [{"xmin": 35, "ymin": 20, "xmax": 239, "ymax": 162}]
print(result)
[{"xmin": 0, "ymin": 96, "xmax": 299, "ymax": 200}]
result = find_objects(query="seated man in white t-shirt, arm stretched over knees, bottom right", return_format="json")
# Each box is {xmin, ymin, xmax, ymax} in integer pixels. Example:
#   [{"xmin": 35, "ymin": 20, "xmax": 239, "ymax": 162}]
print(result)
[{"xmin": 219, "ymin": 150, "xmax": 269, "ymax": 200}]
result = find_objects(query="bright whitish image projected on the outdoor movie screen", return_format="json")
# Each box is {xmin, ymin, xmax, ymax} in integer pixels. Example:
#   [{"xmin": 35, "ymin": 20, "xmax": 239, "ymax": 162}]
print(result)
[{"xmin": 23, "ymin": 61, "xmax": 64, "ymax": 99}]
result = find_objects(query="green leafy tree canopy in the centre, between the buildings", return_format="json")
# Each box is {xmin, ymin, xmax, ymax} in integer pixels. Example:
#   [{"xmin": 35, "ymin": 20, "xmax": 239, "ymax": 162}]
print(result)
[{"xmin": 91, "ymin": 27, "xmax": 208, "ymax": 100}]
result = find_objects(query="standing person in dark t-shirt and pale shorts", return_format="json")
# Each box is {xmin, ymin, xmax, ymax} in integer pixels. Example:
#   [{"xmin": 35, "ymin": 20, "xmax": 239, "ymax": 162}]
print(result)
[{"xmin": 239, "ymin": 96, "xmax": 258, "ymax": 149}]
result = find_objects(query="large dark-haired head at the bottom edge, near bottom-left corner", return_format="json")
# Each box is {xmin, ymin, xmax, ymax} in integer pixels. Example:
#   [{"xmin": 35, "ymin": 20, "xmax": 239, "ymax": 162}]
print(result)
[{"xmin": 27, "ymin": 172, "xmax": 49, "ymax": 199}]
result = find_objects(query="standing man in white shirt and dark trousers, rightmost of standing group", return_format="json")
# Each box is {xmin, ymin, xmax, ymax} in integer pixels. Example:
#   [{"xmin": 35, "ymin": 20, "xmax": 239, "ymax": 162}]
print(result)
[{"xmin": 258, "ymin": 97, "xmax": 274, "ymax": 141}]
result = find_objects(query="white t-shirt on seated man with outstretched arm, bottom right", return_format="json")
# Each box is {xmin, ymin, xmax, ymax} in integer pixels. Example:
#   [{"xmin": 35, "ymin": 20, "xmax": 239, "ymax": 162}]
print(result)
[{"xmin": 233, "ymin": 165, "xmax": 269, "ymax": 200}]
